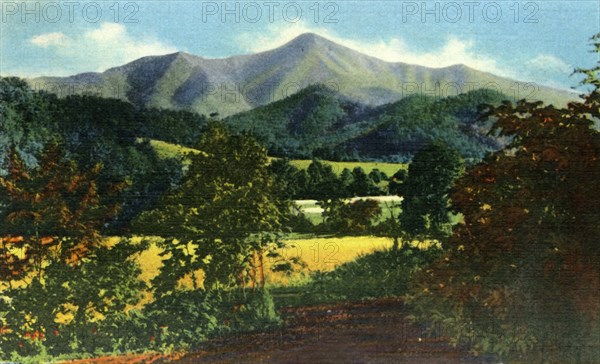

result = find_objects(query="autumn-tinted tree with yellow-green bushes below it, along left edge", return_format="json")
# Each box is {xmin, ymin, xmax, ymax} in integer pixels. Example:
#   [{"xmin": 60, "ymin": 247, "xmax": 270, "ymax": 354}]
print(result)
[{"xmin": 0, "ymin": 144, "xmax": 143, "ymax": 355}]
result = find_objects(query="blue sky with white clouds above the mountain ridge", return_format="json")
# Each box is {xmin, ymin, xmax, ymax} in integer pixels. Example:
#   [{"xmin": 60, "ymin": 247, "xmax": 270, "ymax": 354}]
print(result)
[{"xmin": 0, "ymin": 0, "xmax": 600, "ymax": 89}]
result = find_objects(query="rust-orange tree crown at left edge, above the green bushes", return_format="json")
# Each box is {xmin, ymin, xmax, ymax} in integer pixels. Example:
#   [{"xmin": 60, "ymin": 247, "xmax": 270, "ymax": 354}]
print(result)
[{"xmin": 0, "ymin": 144, "xmax": 122, "ymax": 282}]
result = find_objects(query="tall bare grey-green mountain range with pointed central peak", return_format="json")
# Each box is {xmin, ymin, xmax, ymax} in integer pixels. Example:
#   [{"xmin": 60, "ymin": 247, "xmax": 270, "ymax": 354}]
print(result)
[{"xmin": 29, "ymin": 33, "xmax": 576, "ymax": 116}]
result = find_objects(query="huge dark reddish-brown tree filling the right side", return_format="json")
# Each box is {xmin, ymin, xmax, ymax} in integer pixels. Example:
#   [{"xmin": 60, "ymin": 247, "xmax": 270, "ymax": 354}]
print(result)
[{"xmin": 413, "ymin": 34, "xmax": 600, "ymax": 362}]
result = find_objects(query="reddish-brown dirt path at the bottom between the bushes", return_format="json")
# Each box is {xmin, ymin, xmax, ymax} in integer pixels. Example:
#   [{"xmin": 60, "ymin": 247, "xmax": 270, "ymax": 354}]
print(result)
[{"xmin": 178, "ymin": 300, "xmax": 492, "ymax": 364}]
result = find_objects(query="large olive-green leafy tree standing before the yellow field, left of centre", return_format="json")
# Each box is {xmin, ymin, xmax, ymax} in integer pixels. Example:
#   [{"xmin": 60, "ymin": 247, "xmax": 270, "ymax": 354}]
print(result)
[{"xmin": 138, "ymin": 122, "xmax": 289, "ymax": 293}]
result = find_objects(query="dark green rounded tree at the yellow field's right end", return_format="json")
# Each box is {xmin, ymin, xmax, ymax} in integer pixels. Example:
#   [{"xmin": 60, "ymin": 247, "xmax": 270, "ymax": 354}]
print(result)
[{"xmin": 400, "ymin": 141, "xmax": 464, "ymax": 237}]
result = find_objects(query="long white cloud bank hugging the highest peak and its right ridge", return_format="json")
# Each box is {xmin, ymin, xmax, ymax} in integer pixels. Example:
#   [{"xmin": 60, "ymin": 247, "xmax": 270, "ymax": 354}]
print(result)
[{"xmin": 238, "ymin": 22, "xmax": 515, "ymax": 77}]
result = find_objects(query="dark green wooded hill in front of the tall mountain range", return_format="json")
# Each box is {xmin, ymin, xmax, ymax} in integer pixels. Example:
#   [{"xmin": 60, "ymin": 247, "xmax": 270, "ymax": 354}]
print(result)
[{"xmin": 224, "ymin": 85, "xmax": 506, "ymax": 162}]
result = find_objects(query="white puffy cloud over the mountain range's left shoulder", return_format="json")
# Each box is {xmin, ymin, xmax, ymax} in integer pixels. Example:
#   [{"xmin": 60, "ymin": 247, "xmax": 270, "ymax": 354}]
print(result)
[{"xmin": 31, "ymin": 23, "xmax": 177, "ymax": 74}]
